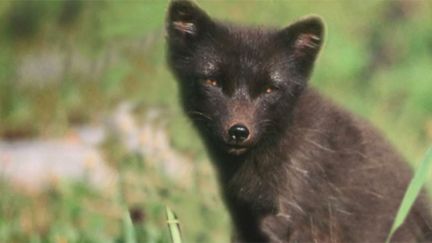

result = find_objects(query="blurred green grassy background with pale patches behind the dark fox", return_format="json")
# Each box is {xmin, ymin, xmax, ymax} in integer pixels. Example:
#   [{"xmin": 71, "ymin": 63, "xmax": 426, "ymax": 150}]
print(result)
[{"xmin": 0, "ymin": 0, "xmax": 432, "ymax": 242}]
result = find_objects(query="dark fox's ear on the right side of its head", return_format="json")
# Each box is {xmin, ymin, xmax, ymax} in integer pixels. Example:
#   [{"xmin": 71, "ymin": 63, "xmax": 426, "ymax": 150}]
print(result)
[{"xmin": 279, "ymin": 16, "xmax": 324, "ymax": 64}]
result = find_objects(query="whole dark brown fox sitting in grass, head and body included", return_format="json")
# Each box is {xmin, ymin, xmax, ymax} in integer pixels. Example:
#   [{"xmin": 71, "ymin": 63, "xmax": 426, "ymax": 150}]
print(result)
[{"xmin": 167, "ymin": 1, "xmax": 432, "ymax": 242}]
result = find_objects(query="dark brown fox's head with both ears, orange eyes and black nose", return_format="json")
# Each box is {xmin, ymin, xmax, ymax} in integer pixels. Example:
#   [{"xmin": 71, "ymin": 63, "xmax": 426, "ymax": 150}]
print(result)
[{"xmin": 166, "ymin": 1, "xmax": 323, "ymax": 156}]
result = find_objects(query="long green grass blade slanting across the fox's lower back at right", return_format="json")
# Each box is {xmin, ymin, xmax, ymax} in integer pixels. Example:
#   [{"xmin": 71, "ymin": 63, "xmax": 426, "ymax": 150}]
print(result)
[{"xmin": 386, "ymin": 148, "xmax": 432, "ymax": 243}]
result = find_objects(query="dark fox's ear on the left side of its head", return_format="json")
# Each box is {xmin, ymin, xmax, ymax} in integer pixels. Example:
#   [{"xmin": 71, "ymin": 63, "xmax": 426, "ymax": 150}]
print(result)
[{"xmin": 167, "ymin": 0, "xmax": 212, "ymax": 44}]
